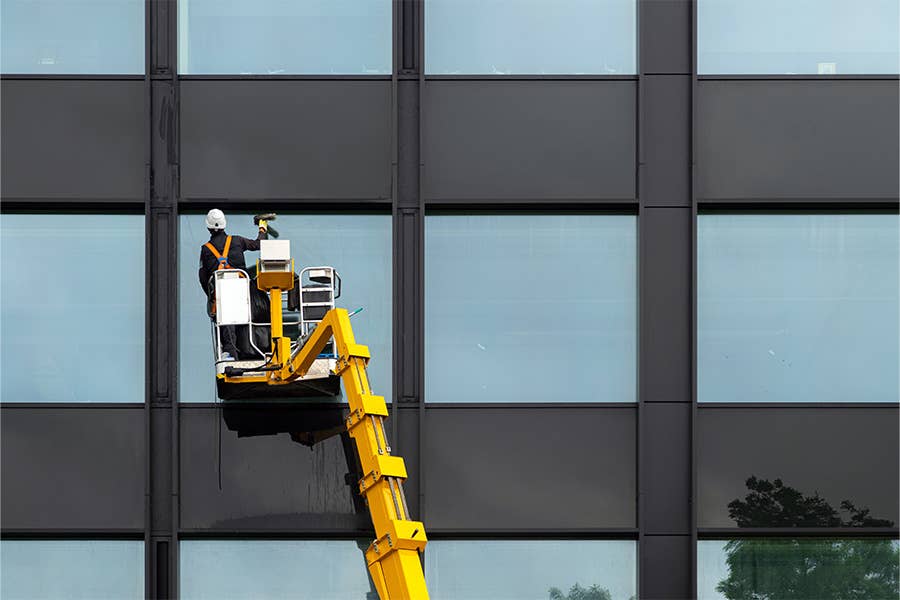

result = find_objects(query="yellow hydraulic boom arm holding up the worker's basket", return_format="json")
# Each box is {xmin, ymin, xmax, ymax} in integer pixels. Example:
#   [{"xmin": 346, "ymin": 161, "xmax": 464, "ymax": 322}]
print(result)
[{"xmin": 225, "ymin": 284, "xmax": 428, "ymax": 600}]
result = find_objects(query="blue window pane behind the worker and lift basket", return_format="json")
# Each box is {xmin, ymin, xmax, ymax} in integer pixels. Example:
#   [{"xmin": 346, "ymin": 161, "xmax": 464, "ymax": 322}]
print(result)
[{"xmin": 178, "ymin": 212, "xmax": 393, "ymax": 402}]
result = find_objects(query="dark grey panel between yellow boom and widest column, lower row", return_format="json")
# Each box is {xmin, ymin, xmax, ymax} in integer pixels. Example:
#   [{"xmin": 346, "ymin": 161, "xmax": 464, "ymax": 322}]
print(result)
[{"xmin": 422, "ymin": 407, "xmax": 636, "ymax": 531}]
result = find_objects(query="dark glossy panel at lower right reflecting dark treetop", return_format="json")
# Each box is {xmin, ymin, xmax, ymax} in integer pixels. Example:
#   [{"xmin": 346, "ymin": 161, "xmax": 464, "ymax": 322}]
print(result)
[{"xmin": 696, "ymin": 405, "xmax": 900, "ymax": 528}]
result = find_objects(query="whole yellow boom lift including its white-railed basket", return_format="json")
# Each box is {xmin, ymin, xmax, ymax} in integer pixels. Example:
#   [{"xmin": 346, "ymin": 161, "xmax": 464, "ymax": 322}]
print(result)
[{"xmin": 207, "ymin": 240, "xmax": 428, "ymax": 600}]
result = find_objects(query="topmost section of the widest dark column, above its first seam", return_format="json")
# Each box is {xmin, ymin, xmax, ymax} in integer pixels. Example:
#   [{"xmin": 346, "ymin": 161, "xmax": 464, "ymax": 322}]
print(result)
[{"xmin": 638, "ymin": 0, "xmax": 693, "ymax": 74}]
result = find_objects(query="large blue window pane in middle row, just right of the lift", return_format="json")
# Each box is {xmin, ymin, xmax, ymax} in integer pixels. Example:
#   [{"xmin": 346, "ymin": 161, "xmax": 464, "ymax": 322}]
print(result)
[{"xmin": 425, "ymin": 214, "xmax": 637, "ymax": 402}]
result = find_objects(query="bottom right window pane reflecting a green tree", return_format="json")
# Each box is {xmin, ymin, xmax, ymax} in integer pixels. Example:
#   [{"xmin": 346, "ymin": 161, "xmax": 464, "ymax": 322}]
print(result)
[{"xmin": 697, "ymin": 538, "xmax": 900, "ymax": 600}]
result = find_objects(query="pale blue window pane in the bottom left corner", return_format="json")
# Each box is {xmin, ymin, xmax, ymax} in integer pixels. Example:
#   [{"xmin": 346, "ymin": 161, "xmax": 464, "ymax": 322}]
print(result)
[{"xmin": 0, "ymin": 540, "xmax": 144, "ymax": 600}]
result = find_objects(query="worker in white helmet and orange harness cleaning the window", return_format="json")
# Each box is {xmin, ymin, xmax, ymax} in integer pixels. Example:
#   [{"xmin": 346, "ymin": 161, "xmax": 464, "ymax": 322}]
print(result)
[{"xmin": 199, "ymin": 208, "xmax": 269, "ymax": 360}]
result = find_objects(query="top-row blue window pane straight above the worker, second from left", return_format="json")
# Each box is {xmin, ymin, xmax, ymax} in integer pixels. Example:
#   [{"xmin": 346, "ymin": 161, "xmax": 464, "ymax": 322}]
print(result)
[{"xmin": 178, "ymin": 0, "xmax": 393, "ymax": 75}]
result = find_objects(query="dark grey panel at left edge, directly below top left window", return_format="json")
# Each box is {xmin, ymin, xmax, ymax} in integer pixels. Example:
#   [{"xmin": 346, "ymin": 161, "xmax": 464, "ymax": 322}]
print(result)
[{"xmin": 0, "ymin": 80, "xmax": 147, "ymax": 202}]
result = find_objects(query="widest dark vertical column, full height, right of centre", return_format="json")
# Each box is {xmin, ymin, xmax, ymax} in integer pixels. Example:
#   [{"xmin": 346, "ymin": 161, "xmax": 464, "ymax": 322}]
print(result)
[{"xmin": 636, "ymin": 0, "xmax": 696, "ymax": 598}]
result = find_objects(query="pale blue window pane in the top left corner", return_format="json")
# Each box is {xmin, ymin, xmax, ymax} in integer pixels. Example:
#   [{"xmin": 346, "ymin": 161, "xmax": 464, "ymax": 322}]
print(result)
[{"xmin": 0, "ymin": 0, "xmax": 146, "ymax": 75}]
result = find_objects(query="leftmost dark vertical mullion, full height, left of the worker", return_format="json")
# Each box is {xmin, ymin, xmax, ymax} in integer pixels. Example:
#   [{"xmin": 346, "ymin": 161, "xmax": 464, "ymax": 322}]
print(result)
[{"xmin": 145, "ymin": 0, "xmax": 177, "ymax": 598}]
